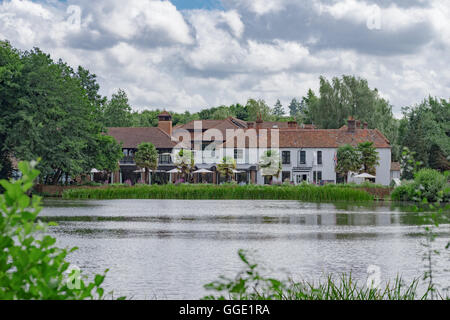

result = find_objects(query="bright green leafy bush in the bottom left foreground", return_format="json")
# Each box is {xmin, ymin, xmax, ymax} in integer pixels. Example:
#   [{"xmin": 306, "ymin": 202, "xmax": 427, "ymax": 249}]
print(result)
[{"xmin": 0, "ymin": 162, "xmax": 112, "ymax": 300}]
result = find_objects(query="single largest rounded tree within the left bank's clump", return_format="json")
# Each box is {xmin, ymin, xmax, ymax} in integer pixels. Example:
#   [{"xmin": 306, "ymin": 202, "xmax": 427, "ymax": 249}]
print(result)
[{"xmin": 6, "ymin": 49, "xmax": 99, "ymax": 184}]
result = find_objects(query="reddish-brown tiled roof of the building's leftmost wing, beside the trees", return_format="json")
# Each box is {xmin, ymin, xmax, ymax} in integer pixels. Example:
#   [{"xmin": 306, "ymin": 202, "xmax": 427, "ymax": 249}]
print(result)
[{"xmin": 108, "ymin": 127, "xmax": 176, "ymax": 149}]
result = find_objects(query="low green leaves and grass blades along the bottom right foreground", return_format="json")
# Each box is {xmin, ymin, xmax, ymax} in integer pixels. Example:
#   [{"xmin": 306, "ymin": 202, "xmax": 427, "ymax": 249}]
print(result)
[{"xmin": 203, "ymin": 250, "xmax": 430, "ymax": 300}]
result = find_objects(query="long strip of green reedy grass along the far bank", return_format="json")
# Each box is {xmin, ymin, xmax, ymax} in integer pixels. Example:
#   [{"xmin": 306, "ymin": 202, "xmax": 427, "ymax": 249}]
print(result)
[{"xmin": 63, "ymin": 185, "xmax": 374, "ymax": 201}]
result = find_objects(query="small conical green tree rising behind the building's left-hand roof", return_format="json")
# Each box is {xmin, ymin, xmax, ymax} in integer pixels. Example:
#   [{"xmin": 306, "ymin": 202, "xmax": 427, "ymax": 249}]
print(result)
[{"xmin": 103, "ymin": 89, "xmax": 133, "ymax": 127}]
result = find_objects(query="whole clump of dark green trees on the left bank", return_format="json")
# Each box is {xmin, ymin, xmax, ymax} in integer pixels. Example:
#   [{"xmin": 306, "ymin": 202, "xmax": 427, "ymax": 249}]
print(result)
[{"xmin": 0, "ymin": 42, "xmax": 124, "ymax": 184}]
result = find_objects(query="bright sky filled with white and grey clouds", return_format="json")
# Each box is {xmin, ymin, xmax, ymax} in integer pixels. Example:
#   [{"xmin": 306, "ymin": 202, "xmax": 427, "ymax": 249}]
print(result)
[{"xmin": 0, "ymin": 0, "xmax": 450, "ymax": 116}]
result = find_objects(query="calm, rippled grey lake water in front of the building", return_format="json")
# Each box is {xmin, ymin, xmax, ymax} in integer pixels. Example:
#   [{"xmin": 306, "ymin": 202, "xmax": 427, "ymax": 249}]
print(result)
[{"xmin": 42, "ymin": 200, "xmax": 450, "ymax": 299}]
